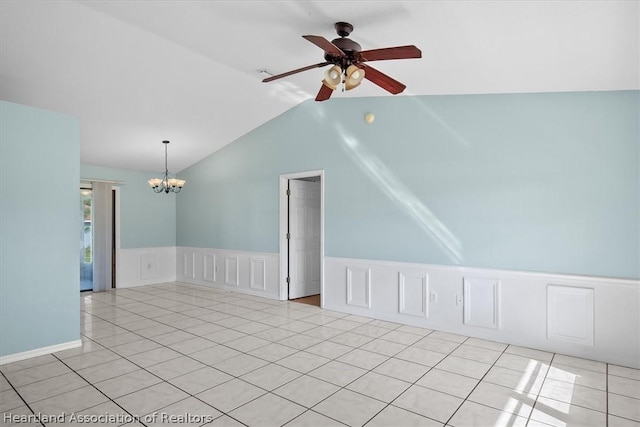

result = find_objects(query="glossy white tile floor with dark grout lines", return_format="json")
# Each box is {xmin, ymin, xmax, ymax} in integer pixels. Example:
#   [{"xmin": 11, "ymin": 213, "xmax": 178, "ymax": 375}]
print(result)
[{"xmin": 0, "ymin": 283, "xmax": 640, "ymax": 427}]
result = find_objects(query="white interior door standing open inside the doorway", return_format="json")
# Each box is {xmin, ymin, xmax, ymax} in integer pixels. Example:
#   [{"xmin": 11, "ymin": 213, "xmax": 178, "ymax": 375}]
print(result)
[{"xmin": 289, "ymin": 179, "xmax": 320, "ymax": 299}]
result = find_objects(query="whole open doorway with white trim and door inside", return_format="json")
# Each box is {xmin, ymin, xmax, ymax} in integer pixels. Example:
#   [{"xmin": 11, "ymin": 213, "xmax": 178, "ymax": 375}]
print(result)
[{"xmin": 280, "ymin": 171, "xmax": 324, "ymax": 306}]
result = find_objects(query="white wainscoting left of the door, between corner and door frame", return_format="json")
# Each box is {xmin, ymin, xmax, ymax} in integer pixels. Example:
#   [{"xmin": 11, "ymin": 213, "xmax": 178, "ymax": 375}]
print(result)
[{"xmin": 176, "ymin": 247, "xmax": 280, "ymax": 299}]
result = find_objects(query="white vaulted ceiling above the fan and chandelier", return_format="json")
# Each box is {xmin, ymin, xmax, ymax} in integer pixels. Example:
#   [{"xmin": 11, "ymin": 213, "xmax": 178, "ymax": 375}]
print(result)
[{"xmin": 0, "ymin": 0, "xmax": 640, "ymax": 172}]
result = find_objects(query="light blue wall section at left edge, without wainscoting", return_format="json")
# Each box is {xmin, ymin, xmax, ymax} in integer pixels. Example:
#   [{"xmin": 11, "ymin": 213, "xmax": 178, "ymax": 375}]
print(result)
[{"xmin": 0, "ymin": 101, "xmax": 81, "ymax": 356}]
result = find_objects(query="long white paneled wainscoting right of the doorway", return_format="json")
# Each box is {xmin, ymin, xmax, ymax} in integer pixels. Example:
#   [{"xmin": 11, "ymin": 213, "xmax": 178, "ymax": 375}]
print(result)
[{"xmin": 324, "ymin": 257, "xmax": 640, "ymax": 368}]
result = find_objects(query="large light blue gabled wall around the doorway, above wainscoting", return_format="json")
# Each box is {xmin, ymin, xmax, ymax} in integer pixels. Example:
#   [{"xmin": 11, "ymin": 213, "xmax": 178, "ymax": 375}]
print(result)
[{"xmin": 177, "ymin": 91, "xmax": 640, "ymax": 278}]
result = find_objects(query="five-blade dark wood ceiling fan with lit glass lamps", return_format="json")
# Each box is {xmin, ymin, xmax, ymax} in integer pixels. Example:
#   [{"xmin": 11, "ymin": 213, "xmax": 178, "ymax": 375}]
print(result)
[{"xmin": 262, "ymin": 22, "xmax": 422, "ymax": 101}]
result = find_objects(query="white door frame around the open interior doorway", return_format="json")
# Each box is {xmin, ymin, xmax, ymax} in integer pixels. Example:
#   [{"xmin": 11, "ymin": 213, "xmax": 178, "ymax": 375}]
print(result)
[{"xmin": 278, "ymin": 169, "xmax": 324, "ymax": 307}]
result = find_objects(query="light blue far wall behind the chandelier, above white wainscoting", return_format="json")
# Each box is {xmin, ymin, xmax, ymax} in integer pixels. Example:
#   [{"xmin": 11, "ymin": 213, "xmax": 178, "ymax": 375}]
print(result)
[{"xmin": 80, "ymin": 164, "xmax": 176, "ymax": 249}]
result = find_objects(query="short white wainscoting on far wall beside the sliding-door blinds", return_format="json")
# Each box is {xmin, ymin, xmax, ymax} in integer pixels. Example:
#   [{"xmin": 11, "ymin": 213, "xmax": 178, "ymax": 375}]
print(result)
[{"xmin": 116, "ymin": 246, "xmax": 176, "ymax": 288}]
